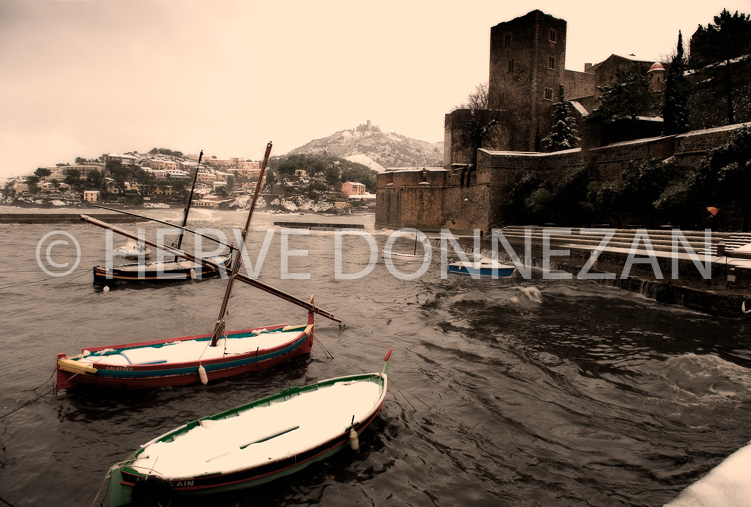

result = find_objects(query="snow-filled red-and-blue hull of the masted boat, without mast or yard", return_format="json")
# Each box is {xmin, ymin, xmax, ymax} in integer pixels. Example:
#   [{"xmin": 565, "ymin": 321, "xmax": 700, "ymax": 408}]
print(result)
[{"xmin": 55, "ymin": 297, "xmax": 314, "ymax": 391}]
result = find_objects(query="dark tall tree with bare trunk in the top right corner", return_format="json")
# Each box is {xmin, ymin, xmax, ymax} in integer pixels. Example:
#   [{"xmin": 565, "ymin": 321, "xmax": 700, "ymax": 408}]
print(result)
[{"xmin": 691, "ymin": 9, "xmax": 751, "ymax": 125}]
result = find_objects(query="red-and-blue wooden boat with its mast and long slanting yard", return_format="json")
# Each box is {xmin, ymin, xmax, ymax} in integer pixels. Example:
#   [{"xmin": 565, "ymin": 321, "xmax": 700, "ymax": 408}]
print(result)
[{"xmin": 56, "ymin": 143, "xmax": 339, "ymax": 390}]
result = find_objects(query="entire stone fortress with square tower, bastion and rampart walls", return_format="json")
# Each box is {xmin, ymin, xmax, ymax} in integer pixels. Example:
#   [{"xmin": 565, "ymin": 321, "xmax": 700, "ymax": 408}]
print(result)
[{"xmin": 376, "ymin": 10, "xmax": 751, "ymax": 232}]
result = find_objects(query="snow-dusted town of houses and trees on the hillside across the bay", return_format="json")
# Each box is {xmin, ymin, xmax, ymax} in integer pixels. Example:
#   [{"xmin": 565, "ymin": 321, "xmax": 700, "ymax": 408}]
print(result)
[{"xmin": 0, "ymin": 148, "xmax": 375, "ymax": 213}]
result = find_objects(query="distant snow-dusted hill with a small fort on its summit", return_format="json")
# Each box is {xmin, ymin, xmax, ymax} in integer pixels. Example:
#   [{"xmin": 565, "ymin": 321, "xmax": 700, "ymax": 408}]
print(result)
[{"xmin": 289, "ymin": 122, "xmax": 443, "ymax": 172}]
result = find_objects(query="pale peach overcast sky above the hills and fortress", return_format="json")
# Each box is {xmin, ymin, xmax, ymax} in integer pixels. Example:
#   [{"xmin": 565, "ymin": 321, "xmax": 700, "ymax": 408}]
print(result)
[{"xmin": 0, "ymin": 0, "xmax": 751, "ymax": 177}]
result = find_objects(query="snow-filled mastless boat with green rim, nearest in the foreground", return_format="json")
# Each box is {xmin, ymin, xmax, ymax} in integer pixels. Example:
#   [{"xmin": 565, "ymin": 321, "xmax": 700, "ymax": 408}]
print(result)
[{"xmin": 108, "ymin": 350, "xmax": 391, "ymax": 507}]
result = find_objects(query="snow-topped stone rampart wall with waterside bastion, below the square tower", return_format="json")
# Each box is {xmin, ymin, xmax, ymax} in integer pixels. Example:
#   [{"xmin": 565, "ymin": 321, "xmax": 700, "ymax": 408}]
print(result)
[{"xmin": 376, "ymin": 123, "xmax": 751, "ymax": 232}]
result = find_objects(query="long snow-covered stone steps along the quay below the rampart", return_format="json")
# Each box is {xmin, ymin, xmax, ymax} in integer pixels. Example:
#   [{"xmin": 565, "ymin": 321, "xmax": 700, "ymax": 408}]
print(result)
[{"xmin": 502, "ymin": 226, "xmax": 736, "ymax": 255}]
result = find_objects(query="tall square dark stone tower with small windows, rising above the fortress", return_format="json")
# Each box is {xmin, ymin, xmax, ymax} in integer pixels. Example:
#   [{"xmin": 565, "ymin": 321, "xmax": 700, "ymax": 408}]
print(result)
[{"xmin": 488, "ymin": 10, "xmax": 566, "ymax": 151}]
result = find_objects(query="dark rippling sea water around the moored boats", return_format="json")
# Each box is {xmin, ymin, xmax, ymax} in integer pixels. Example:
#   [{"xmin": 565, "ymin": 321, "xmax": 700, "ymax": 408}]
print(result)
[{"xmin": 0, "ymin": 209, "xmax": 751, "ymax": 506}]
